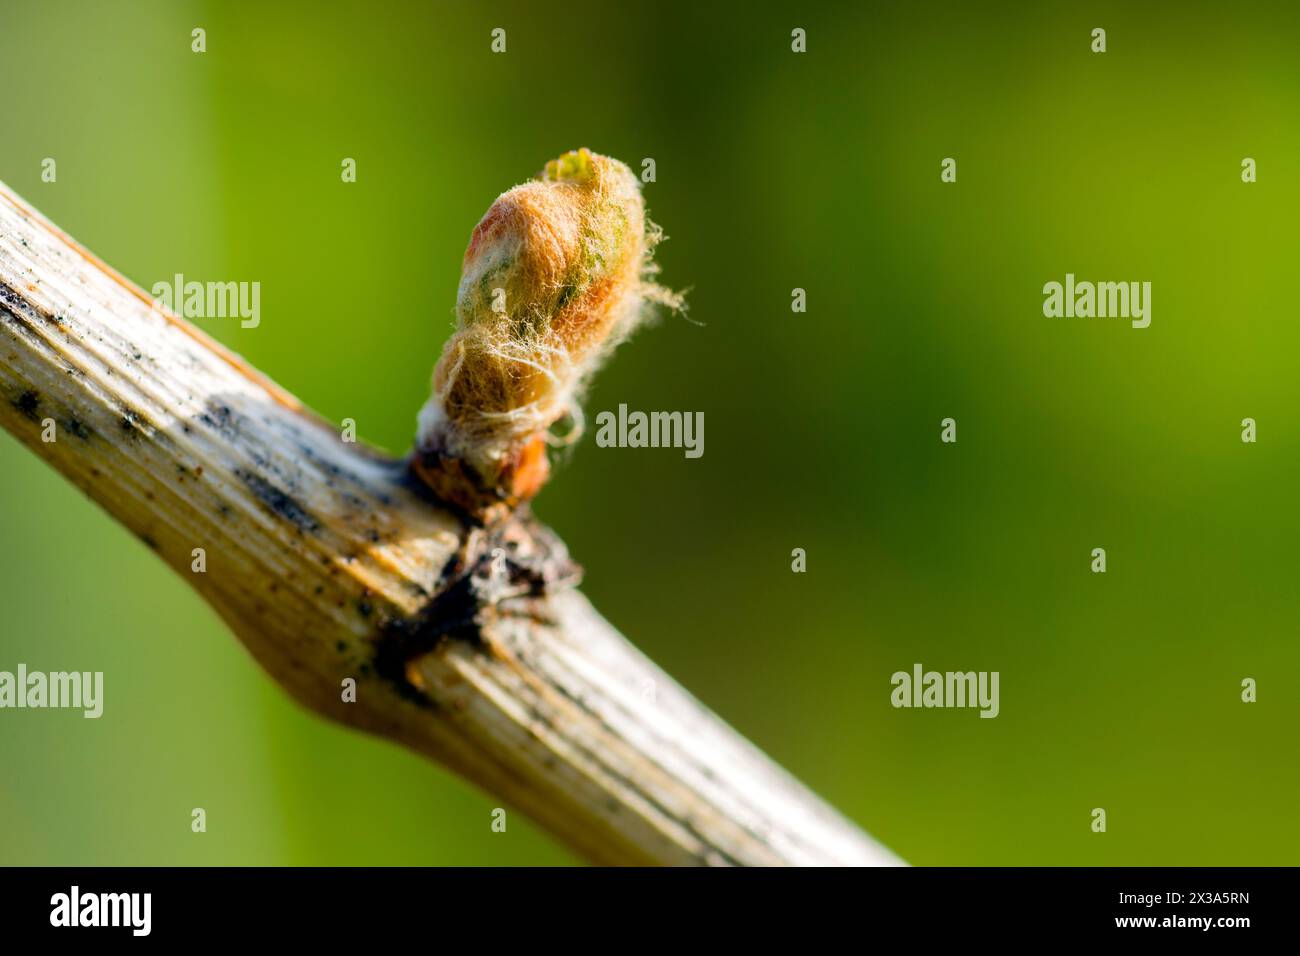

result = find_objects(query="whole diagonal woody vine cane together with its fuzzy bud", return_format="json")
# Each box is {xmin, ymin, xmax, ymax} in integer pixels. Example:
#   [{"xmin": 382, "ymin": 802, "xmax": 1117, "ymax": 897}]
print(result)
[{"xmin": 0, "ymin": 151, "xmax": 898, "ymax": 865}]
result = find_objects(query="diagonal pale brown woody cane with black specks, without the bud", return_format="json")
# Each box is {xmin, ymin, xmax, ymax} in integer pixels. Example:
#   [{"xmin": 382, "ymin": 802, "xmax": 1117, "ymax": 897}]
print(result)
[{"xmin": 0, "ymin": 185, "xmax": 898, "ymax": 865}]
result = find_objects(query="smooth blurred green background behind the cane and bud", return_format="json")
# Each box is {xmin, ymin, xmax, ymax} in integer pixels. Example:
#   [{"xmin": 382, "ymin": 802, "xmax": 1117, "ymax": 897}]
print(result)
[{"xmin": 0, "ymin": 0, "xmax": 1300, "ymax": 865}]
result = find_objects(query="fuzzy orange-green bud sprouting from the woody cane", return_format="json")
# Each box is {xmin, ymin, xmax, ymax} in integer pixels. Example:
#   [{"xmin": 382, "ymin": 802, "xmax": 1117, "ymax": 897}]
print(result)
[{"xmin": 413, "ymin": 150, "xmax": 677, "ymax": 512}]
